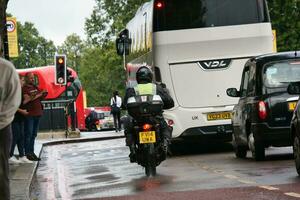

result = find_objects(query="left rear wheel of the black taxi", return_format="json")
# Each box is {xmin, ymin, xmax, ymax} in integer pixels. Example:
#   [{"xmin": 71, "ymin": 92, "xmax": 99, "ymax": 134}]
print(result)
[{"xmin": 248, "ymin": 133, "xmax": 265, "ymax": 161}]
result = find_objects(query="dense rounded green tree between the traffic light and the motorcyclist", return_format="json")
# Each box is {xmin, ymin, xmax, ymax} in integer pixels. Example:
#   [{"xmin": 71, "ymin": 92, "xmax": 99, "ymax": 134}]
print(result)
[{"xmin": 80, "ymin": 42, "xmax": 125, "ymax": 106}]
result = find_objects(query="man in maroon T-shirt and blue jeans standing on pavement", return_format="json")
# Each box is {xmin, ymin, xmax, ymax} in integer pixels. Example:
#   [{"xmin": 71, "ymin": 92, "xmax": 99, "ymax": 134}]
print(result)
[{"xmin": 23, "ymin": 72, "xmax": 48, "ymax": 161}]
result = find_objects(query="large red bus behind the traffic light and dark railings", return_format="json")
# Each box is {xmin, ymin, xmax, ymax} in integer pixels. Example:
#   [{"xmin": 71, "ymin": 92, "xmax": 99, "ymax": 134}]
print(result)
[{"xmin": 17, "ymin": 66, "xmax": 86, "ymax": 130}]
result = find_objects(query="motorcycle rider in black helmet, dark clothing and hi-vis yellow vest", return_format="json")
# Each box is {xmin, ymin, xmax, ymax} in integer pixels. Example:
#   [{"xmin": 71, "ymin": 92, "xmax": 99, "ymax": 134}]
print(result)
[{"xmin": 124, "ymin": 66, "xmax": 174, "ymax": 162}]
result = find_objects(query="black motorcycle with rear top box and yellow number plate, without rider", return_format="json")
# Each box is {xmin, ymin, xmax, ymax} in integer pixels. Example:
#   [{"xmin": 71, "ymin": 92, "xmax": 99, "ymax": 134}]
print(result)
[{"xmin": 127, "ymin": 95, "xmax": 166, "ymax": 176}]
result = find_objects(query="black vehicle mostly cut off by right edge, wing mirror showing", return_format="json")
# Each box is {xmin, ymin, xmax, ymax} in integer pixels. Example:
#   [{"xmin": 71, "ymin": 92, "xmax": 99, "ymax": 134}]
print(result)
[{"xmin": 288, "ymin": 76, "xmax": 300, "ymax": 176}]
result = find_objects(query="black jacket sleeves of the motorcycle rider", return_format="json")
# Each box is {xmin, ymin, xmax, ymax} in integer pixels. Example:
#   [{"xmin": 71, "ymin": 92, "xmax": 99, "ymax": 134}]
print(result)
[{"xmin": 124, "ymin": 84, "xmax": 174, "ymax": 109}]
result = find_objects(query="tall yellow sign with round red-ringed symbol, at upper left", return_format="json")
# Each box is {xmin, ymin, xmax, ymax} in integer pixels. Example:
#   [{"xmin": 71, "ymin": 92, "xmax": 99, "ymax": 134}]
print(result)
[{"xmin": 6, "ymin": 17, "xmax": 19, "ymax": 58}]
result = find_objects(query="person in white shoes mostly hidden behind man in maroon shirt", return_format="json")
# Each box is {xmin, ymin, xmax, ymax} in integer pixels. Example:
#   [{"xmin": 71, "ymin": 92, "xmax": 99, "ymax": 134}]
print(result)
[{"xmin": 9, "ymin": 75, "xmax": 32, "ymax": 164}]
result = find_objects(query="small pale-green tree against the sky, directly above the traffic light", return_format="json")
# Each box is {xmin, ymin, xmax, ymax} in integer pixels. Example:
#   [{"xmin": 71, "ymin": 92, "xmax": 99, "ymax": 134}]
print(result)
[{"xmin": 58, "ymin": 33, "xmax": 85, "ymax": 72}]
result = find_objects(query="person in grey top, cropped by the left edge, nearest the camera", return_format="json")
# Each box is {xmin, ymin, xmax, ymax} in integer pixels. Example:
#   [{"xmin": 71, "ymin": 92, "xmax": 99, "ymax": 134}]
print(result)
[{"xmin": 0, "ymin": 58, "xmax": 21, "ymax": 200}]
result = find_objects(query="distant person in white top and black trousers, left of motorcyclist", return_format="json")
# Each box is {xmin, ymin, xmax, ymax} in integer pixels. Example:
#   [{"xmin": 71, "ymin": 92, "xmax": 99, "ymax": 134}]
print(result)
[{"xmin": 110, "ymin": 91, "xmax": 122, "ymax": 132}]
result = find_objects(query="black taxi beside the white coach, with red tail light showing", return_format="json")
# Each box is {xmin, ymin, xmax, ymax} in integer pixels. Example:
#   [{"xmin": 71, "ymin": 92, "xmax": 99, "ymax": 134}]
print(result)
[{"xmin": 226, "ymin": 52, "xmax": 300, "ymax": 160}]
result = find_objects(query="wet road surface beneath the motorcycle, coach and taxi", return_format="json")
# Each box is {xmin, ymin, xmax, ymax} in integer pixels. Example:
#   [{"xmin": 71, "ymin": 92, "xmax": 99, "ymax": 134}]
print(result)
[{"xmin": 31, "ymin": 132, "xmax": 300, "ymax": 200}]
